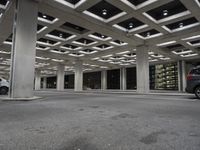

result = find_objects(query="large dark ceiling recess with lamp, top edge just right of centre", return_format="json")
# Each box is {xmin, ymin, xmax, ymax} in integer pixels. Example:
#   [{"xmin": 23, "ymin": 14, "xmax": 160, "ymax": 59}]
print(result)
[{"xmin": 83, "ymin": 0, "xmax": 126, "ymax": 22}]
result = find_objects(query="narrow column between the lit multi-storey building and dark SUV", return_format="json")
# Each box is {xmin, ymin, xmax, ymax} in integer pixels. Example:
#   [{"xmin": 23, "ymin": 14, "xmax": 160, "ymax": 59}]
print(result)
[{"xmin": 177, "ymin": 60, "xmax": 187, "ymax": 92}]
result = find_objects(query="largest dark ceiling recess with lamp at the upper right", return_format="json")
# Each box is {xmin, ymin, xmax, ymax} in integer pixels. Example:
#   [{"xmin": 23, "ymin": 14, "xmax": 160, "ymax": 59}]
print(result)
[{"xmin": 146, "ymin": 0, "xmax": 188, "ymax": 21}]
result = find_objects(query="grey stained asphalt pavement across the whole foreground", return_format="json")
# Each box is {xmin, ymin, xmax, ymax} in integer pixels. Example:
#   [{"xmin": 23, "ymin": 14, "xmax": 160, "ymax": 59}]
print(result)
[{"xmin": 0, "ymin": 91, "xmax": 200, "ymax": 150}]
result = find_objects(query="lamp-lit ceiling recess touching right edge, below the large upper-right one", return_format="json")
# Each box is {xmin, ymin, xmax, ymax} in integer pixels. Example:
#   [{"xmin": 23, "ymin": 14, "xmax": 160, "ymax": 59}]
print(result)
[{"xmin": 164, "ymin": 17, "xmax": 199, "ymax": 32}]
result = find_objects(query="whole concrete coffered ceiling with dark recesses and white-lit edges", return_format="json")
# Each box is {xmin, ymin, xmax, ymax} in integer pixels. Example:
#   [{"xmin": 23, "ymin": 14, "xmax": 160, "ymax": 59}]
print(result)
[{"xmin": 0, "ymin": 0, "xmax": 200, "ymax": 74}]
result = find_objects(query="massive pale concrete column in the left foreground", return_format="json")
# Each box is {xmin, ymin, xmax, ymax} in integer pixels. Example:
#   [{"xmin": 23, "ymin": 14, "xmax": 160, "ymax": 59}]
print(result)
[{"xmin": 9, "ymin": 0, "xmax": 38, "ymax": 98}]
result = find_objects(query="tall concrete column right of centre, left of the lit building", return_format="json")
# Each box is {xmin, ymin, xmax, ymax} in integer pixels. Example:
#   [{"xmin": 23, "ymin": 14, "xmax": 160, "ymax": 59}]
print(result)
[{"xmin": 136, "ymin": 45, "xmax": 149, "ymax": 93}]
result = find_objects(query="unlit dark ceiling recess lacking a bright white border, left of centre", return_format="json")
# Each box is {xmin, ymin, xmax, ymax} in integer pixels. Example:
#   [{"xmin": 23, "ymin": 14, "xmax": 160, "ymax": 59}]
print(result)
[{"xmin": 61, "ymin": 22, "xmax": 89, "ymax": 34}]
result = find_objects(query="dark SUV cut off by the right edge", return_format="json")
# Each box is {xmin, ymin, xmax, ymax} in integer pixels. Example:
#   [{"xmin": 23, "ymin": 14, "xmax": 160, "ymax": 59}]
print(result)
[{"xmin": 186, "ymin": 66, "xmax": 200, "ymax": 99}]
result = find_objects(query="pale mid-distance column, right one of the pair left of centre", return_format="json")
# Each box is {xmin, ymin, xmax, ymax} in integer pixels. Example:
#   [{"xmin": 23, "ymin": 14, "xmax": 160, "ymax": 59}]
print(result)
[{"xmin": 74, "ymin": 60, "xmax": 83, "ymax": 91}]
